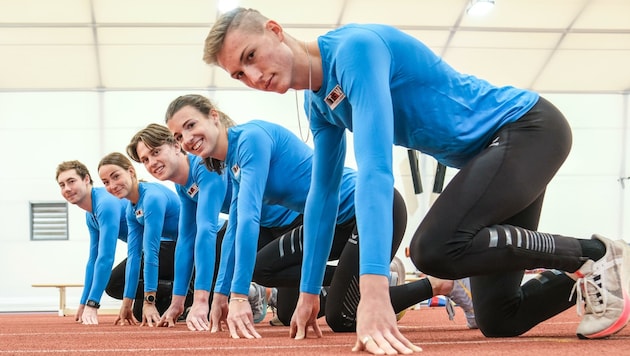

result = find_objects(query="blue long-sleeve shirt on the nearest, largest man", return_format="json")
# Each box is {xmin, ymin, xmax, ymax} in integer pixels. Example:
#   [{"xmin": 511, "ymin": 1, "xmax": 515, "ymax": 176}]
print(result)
[{"xmin": 302, "ymin": 25, "xmax": 538, "ymax": 288}]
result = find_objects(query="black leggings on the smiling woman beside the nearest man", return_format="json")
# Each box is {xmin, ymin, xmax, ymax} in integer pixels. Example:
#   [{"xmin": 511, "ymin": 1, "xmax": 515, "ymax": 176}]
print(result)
[{"xmin": 254, "ymin": 190, "xmax": 412, "ymax": 332}]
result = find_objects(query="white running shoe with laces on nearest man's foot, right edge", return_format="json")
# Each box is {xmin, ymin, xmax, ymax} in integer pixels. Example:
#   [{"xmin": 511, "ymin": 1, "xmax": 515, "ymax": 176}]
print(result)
[{"xmin": 569, "ymin": 235, "xmax": 630, "ymax": 339}]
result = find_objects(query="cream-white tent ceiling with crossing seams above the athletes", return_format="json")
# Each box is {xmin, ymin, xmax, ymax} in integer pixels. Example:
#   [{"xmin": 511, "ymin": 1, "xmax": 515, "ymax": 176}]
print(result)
[{"xmin": 0, "ymin": 0, "xmax": 630, "ymax": 93}]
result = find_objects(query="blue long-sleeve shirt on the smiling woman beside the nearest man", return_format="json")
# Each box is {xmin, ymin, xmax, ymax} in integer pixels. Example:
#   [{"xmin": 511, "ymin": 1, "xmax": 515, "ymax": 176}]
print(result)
[{"xmin": 217, "ymin": 120, "xmax": 356, "ymax": 294}]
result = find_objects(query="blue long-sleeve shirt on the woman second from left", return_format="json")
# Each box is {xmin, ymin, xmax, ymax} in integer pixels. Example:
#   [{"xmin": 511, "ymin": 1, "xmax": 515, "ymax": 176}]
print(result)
[{"xmin": 124, "ymin": 182, "xmax": 180, "ymax": 299}]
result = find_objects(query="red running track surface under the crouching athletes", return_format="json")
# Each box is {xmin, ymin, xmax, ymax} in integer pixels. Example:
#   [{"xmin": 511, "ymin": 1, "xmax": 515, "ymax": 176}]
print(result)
[{"xmin": 0, "ymin": 307, "xmax": 630, "ymax": 356}]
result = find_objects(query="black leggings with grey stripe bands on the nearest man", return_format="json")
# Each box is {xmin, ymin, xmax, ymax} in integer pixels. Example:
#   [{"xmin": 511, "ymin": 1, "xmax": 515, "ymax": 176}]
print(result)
[{"xmin": 410, "ymin": 98, "xmax": 584, "ymax": 337}]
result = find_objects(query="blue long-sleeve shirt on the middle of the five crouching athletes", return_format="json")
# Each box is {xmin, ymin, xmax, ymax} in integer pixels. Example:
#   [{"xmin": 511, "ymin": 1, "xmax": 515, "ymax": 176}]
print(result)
[{"xmin": 173, "ymin": 154, "xmax": 299, "ymax": 296}]
